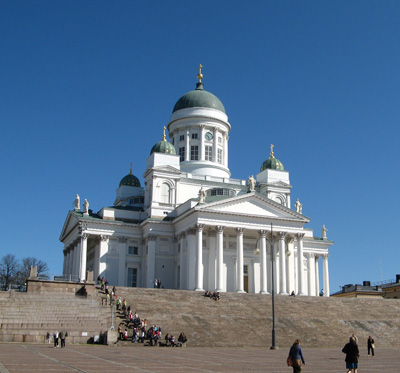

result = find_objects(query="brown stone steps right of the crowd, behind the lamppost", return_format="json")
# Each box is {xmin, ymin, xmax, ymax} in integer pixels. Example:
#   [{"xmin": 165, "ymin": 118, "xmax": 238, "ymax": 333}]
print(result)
[{"xmin": 111, "ymin": 288, "xmax": 400, "ymax": 347}]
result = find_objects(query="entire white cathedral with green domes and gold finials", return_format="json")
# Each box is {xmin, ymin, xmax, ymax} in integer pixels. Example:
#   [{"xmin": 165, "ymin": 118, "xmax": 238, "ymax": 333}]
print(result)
[{"xmin": 60, "ymin": 67, "xmax": 333, "ymax": 296}]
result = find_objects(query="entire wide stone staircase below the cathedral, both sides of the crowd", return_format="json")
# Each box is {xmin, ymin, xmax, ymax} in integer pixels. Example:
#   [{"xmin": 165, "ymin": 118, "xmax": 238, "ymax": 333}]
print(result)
[{"xmin": 0, "ymin": 288, "xmax": 400, "ymax": 348}]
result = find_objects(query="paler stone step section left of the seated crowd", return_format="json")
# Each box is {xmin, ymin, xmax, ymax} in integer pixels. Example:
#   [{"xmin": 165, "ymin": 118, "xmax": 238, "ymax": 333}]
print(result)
[{"xmin": 0, "ymin": 292, "xmax": 111, "ymax": 343}]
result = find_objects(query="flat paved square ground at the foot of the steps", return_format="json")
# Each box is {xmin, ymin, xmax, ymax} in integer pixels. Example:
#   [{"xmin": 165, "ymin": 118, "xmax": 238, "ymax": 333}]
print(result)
[{"xmin": 0, "ymin": 343, "xmax": 400, "ymax": 373}]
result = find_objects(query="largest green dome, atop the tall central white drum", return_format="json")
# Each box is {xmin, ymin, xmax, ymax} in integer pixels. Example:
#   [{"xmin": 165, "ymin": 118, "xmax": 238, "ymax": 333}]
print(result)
[{"xmin": 172, "ymin": 82, "xmax": 226, "ymax": 114}]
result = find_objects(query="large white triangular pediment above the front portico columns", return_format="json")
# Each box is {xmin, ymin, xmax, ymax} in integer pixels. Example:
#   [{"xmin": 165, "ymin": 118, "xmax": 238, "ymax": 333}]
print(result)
[{"xmin": 196, "ymin": 192, "xmax": 310, "ymax": 223}]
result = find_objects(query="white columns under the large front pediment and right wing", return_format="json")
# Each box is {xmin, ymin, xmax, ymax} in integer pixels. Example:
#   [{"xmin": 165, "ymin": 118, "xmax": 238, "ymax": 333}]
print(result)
[{"xmin": 186, "ymin": 224, "xmax": 329, "ymax": 296}]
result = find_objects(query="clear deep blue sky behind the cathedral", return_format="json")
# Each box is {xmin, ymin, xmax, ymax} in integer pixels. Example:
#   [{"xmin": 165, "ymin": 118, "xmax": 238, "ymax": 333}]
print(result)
[{"xmin": 0, "ymin": 0, "xmax": 400, "ymax": 292}]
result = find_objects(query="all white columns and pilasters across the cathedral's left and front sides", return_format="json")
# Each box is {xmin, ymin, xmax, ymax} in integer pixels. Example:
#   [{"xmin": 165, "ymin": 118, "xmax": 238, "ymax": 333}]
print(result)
[{"xmin": 63, "ymin": 224, "xmax": 329, "ymax": 296}]
